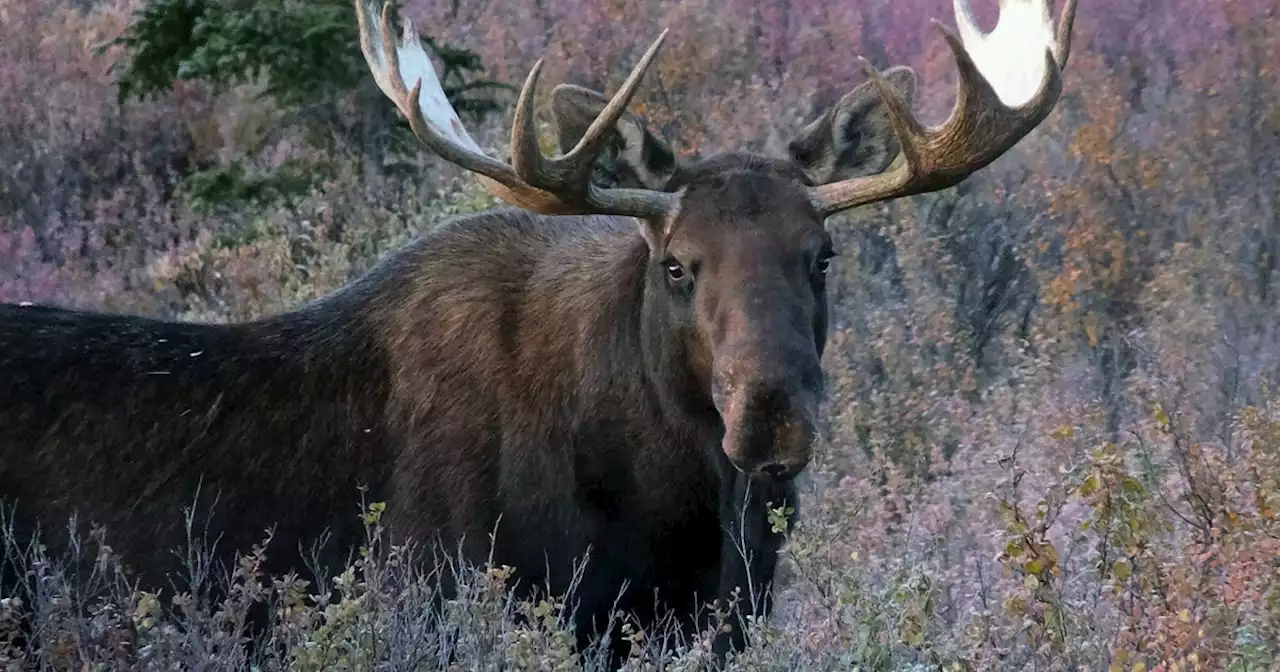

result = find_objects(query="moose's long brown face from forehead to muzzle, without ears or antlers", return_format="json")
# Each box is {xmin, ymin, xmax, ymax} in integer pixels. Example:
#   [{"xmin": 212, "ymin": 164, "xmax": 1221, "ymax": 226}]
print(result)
[{"xmin": 665, "ymin": 170, "xmax": 835, "ymax": 480}]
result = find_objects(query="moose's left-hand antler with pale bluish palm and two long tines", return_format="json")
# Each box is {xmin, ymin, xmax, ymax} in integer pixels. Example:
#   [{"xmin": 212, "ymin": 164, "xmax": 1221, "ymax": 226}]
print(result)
[{"xmin": 355, "ymin": 0, "xmax": 676, "ymax": 219}]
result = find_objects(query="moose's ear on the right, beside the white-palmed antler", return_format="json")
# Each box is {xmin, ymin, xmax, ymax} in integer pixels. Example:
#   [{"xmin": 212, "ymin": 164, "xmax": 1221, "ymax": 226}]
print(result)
[{"xmin": 787, "ymin": 65, "xmax": 915, "ymax": 184}]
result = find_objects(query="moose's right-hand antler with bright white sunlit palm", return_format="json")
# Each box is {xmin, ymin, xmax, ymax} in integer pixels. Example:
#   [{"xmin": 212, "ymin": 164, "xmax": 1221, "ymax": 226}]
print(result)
[{"xmin": 809, "ymin": 0, "xmax": 1076, "ymax": 215}]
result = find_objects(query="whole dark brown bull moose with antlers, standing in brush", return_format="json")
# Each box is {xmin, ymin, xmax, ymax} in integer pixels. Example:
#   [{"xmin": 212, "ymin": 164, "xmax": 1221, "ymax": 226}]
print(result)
[{"xmin": 0, "ymin": 0, "xmax": 1075, "ymax": 649}]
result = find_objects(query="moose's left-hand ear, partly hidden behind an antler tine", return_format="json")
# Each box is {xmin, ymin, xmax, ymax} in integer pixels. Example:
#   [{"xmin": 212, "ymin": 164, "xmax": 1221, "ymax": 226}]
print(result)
[{"xmin": 550, "ymin": 84, "xmax": 678, "ymax": 191}]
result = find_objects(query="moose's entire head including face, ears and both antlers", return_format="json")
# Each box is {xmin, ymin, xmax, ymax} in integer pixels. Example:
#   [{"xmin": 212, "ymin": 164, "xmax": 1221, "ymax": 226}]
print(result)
[{"xmin": 356, "ymin": 0, "xmax": 1075, "ymax": 480}]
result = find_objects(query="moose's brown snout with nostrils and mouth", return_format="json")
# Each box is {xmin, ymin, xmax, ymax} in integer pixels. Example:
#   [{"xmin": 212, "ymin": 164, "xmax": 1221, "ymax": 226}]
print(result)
[{"xmin": 712, "ymin": 366, "xmax": 817, "ymax": 480}]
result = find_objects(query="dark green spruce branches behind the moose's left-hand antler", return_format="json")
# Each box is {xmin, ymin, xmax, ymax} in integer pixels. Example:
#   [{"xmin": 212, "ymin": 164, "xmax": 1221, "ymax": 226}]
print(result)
[{"xmin": 100, "ymin": 0, "xmax": 512, "ymax": 210}]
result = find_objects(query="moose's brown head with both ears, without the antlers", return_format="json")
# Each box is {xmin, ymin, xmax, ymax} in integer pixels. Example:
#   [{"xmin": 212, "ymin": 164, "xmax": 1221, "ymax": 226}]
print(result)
[{"xmin": 552, "ymin": 73, "xmax": 915, "ymax": 480}]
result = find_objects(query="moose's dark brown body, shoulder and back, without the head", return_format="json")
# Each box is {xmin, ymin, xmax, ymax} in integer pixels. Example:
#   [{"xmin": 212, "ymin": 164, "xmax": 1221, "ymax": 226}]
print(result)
[{"xmin": 0, "ymin": 204, "xmax": 791, "ymax": 645}]
